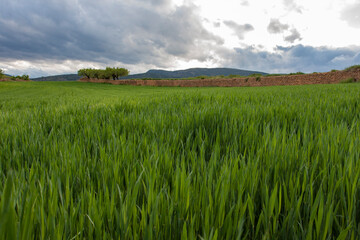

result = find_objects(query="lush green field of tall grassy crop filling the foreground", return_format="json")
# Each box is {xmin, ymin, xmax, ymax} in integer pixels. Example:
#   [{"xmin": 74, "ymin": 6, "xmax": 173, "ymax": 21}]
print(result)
[{"xmin": 0, "ymin": 82, "xmax": 360, "ymax": 239}]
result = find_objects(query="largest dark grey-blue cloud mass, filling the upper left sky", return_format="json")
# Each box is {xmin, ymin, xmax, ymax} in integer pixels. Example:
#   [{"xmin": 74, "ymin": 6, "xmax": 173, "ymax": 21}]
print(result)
[{"xmin": 0, "ymin": 0, "xmax": 223, "ymax": 66}]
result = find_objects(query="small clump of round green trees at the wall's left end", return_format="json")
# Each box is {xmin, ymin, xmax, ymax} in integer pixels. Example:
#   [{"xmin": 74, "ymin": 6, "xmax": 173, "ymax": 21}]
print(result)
[{"xmin": 78, "ymin": 67, "xmax": 129, "ymax": 80}]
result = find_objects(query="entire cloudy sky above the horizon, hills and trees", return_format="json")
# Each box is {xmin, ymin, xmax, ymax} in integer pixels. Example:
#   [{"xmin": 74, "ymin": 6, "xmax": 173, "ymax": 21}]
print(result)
[{"xmin": 0, "ymin": 0, "xmax": 360, "ymax": 77}]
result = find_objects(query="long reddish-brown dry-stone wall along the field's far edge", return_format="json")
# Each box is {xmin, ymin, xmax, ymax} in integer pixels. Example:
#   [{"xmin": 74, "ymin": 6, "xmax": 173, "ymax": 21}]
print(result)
[{"xmin": 80, "ymin": 69, "xmax": 360, "ymax": 87}]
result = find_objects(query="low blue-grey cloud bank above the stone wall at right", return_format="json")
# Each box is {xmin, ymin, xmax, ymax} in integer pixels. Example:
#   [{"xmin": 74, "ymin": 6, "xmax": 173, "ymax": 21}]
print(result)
[{"xmin": 223, "ymin": 45, "xmax": 360, "ymax": 73}]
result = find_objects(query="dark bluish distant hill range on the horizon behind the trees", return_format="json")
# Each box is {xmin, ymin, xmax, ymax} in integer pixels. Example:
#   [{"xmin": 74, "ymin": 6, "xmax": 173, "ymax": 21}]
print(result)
[{"xmin": 31, "ymin": 68, "xmax": 267, "ymax": 81}]
